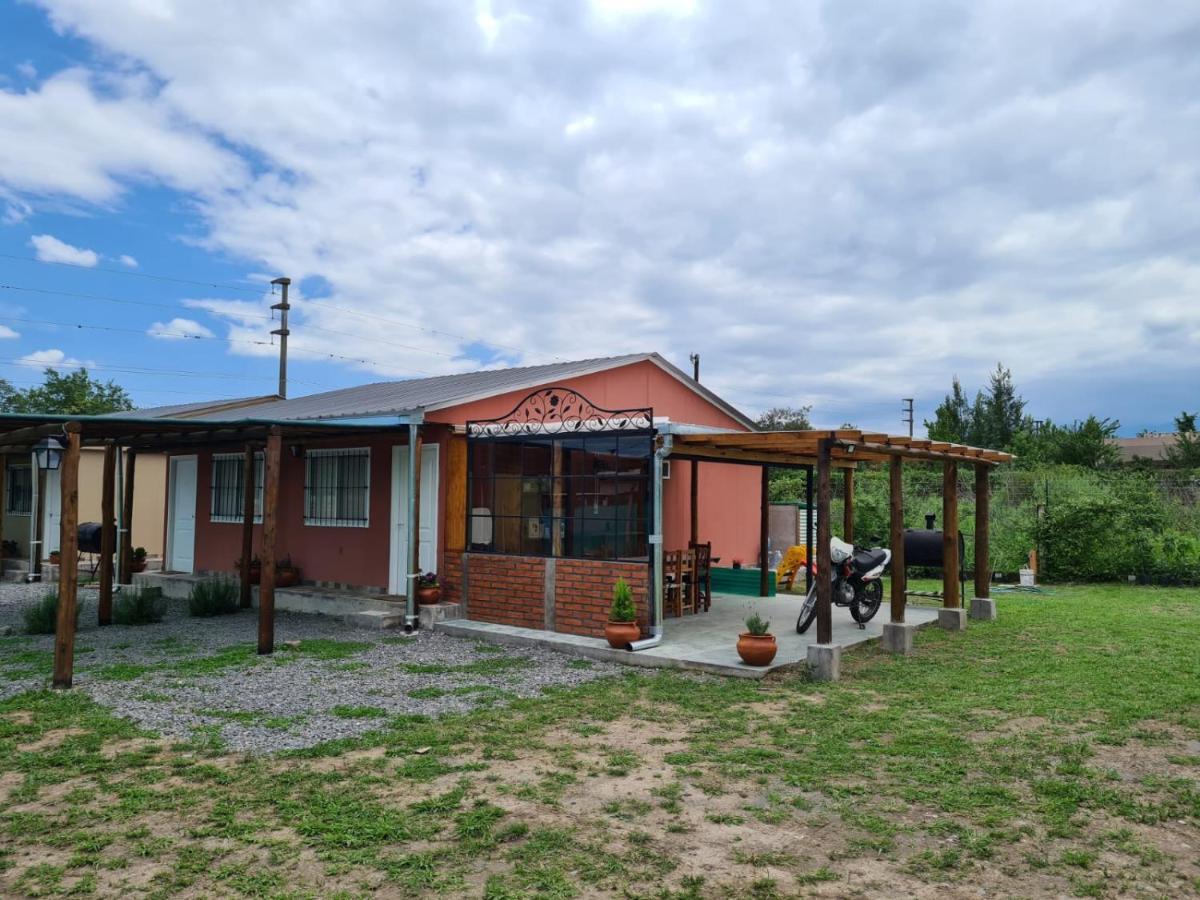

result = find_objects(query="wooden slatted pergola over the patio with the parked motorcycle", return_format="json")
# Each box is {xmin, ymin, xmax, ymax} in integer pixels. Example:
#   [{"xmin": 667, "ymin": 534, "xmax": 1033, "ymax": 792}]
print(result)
[{"xmin": 671, "ymin": 428, "xmax": 1013, "ymax": 644}]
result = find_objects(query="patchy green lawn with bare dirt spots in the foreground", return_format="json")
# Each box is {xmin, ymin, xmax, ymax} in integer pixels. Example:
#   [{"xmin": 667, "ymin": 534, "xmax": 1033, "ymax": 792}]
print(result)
[{"xmin": 0, "ymin": 586, "xmax": 1200, "ymax": 899}]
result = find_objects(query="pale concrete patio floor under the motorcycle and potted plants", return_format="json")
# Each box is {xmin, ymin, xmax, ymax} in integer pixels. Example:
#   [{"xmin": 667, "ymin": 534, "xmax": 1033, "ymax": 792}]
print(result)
[{"xmin": 437, "ymin": 594, "xmax": 937, "ymax": 678}]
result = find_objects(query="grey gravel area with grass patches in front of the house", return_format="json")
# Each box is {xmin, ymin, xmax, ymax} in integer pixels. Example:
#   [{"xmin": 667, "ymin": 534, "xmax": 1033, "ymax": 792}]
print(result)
[{"xmin": 0, "ymin": 583, "xmax": 622, "ymax": 754}]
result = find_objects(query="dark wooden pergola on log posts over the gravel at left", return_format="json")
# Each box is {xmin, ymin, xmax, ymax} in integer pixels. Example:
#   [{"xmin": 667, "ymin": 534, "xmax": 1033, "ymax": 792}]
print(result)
[{"xmin": 0, "ymin": 414, "xmax": 420, "ymax": 688}]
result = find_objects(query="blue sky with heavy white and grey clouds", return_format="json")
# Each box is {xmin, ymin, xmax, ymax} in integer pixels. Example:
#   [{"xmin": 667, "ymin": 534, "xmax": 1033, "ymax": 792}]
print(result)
[{"xmin": 0, "ymin": 0, "xmax": 1200, "ymax": 434}]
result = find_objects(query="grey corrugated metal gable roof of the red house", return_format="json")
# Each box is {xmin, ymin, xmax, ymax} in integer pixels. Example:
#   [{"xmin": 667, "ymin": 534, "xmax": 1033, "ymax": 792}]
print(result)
[{"xmin": 126, "ymin": 353, "xmax": 754, "ymax": 428}]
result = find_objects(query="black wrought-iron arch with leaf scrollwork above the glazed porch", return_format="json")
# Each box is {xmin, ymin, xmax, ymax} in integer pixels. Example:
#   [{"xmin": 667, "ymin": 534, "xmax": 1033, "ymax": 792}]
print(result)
[{"xmin": 467, "ymin": 388, "xmax": 654, "ymax": 438}]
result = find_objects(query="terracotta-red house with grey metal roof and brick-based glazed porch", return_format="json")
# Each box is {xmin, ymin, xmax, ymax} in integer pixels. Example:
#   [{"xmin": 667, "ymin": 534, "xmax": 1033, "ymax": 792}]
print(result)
[{"xmin": 116, "ymin": 353, "xmax": 761, "ymax": 635}]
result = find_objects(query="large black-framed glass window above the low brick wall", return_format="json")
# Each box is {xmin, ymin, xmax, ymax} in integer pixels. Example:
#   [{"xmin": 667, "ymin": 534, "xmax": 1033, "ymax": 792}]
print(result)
[{"xmin": 468, "ymin": 434, "xmax": 653, "ymax": 559}]
